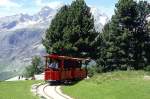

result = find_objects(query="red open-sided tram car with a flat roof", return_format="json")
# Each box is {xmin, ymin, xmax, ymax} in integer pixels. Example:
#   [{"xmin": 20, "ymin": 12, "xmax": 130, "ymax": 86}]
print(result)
[{"xmin": 44, "ymin": 54, "xmax": 87, "ymax": 82}]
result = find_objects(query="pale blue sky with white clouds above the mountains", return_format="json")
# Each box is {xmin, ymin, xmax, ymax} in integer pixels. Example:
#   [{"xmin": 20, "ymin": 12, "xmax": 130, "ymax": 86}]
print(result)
[{"xmin": 0, "ymin": 0, "xmax": 150, "ymax": 17}]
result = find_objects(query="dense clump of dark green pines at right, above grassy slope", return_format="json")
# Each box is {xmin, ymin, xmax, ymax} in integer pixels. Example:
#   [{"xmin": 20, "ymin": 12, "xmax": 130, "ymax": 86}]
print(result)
[{"xmin": 98, "ymin": 0, "xmax": 150, "ymax": 71}]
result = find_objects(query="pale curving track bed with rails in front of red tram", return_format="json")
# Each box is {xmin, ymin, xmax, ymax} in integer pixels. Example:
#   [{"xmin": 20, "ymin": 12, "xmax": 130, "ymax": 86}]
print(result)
[{"xmin": 36, "ymin": 84, "xmax": 72, "ymax": 99}]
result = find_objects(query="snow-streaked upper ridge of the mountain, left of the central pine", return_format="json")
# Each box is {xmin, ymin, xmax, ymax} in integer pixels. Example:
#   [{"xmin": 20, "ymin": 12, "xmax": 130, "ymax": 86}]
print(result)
[{"xmin": 0, "ymin": 7, "xmax": 57, "ymax": 31}]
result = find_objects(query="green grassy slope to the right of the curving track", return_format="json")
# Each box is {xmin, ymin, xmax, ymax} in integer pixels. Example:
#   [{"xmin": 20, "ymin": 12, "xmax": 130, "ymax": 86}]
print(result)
[{"xmin": 62, "ymin": 71, "xmax": 150, "ymax": 99}]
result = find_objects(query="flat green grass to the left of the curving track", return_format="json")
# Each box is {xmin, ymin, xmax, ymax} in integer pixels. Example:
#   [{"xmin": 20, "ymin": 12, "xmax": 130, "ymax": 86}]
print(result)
[{"xmin": 0, "ymin": 81, "xmax": 41, "ymax": 99}]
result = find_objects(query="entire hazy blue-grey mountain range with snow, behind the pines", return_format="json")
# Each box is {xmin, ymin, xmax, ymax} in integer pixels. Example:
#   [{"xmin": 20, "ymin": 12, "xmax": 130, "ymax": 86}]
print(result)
[{"xmin": 0, "ymin": 7, "xmax": 108, "ymax": 80}]
